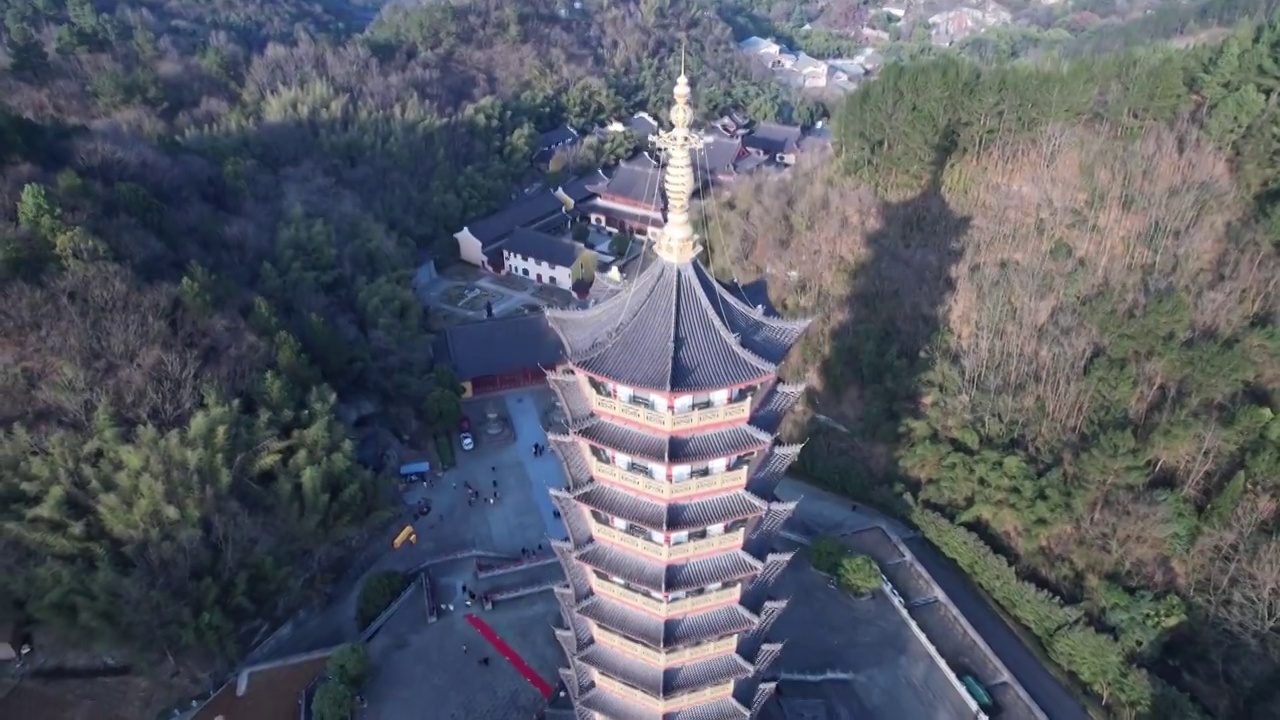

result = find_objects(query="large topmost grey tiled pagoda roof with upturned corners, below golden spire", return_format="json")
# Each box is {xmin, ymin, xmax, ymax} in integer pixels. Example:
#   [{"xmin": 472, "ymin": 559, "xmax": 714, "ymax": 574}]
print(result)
[{"xmin": 547, "ymin": 257, "xmax": 783, "ymax": 392}]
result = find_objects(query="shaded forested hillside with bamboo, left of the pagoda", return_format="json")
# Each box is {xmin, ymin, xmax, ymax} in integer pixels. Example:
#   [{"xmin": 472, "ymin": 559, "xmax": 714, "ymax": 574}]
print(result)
[{"xmin": 0, "ymin": 0, "xmax": 817, "ymax": 717}]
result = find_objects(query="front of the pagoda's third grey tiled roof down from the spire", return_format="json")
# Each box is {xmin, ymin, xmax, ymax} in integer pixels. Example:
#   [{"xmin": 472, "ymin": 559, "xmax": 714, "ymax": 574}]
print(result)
[{"xmin": 573, "ymin": 482, "xmax": 768, "ymax": 532}]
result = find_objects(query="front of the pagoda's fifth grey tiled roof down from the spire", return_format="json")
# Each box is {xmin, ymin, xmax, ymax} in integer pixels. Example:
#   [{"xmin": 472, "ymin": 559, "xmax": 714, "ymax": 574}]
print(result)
[{"xmin": 577, "ymin": 596, "xmax": 760, "ymax": 650}]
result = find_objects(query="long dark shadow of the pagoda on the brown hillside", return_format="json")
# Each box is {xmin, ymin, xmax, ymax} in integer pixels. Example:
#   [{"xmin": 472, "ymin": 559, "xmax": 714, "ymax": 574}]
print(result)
[{"xmin": 801, "ymin": 145, "xmax": 970, "ymax": 512}]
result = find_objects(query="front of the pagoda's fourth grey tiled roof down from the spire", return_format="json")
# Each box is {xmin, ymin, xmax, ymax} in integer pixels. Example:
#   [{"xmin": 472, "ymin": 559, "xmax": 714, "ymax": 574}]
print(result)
[{"xmin": 576, "ymin": 542, "xmax": 764, "ymax": 592}]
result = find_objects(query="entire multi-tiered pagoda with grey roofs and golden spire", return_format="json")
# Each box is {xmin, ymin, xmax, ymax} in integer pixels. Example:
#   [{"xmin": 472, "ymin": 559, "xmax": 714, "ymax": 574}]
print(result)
[{"xmin": 548, "ymin": 68, "xmax": 808, "ymax": 720}]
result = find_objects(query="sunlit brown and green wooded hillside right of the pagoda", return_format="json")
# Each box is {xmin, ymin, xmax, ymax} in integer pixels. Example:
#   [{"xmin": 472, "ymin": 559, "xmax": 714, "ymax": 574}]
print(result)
[{"xmin": 712, "ymin": 23, "xmax": 1280, "ymax": 719}]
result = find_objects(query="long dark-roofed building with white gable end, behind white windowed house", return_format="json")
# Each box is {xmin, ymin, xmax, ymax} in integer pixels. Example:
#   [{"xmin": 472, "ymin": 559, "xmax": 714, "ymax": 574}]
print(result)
[{"xmin": 453, "ymin": 172, "xmax": 604, "ymax": 273}]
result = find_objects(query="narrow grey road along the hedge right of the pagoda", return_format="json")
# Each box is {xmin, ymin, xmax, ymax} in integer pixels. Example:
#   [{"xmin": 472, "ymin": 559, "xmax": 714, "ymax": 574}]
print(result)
[{"xmin": 777, "ymin": 478, "xmax": 1089, "ymax": 720}]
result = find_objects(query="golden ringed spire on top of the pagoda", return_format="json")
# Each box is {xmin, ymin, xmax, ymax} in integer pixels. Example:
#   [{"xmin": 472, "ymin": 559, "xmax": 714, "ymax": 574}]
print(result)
[{"xmin": 654, "ymin": 56, "xmax": 703, "ymax": 263}]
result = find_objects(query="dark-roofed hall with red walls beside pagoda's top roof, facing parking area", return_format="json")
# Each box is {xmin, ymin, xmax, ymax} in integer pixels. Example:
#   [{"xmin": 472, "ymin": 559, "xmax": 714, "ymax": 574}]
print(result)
[{"xmin": 435, "ymin": 313, "xmax": 564, "ymax": 397}]
